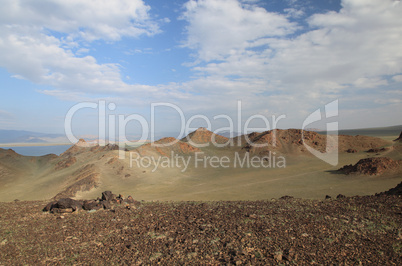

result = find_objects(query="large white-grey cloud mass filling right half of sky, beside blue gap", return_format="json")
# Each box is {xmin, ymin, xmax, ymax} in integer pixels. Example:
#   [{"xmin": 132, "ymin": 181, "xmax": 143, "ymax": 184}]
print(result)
[{"xmin": 185, "ymin": 0, "xmax": 402, "ymax": 106}]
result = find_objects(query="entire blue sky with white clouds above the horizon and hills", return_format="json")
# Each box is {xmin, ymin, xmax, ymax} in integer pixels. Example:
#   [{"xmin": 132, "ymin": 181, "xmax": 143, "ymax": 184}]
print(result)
[{"xmin": 0, "ymin": 0, "xmax": 402, "ymax": 135}]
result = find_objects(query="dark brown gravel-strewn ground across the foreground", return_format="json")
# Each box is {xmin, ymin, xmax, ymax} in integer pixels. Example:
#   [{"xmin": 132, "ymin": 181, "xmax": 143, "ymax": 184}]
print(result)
[{"xmin": 0, "ymin": 191, "xmax": 402, "ymax": 265}]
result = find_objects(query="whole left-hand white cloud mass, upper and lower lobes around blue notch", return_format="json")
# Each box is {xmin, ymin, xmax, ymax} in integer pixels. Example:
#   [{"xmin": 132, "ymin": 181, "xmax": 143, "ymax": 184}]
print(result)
[{"xmin": 0, "ymin": 0, "xmax": 159, "ymax": 93}]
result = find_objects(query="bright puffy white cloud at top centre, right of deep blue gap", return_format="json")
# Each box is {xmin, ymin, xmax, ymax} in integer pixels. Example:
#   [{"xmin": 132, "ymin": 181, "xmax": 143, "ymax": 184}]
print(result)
[{"xmin": 182, "ymin": 0, "xmax": 296, "ymax": 61}]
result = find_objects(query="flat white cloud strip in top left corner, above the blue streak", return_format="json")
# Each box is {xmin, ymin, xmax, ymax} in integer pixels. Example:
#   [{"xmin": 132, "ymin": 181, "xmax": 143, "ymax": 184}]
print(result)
[{"xmin": 0, "ymin": 0, "xmax": 159, "ymax": 41}]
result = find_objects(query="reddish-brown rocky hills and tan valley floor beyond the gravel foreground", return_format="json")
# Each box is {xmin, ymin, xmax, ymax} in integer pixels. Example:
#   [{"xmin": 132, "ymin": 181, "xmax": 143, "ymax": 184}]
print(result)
[{"xmin": 0, "ymin": 128, "xmax": 402, "ymax": 201}]
